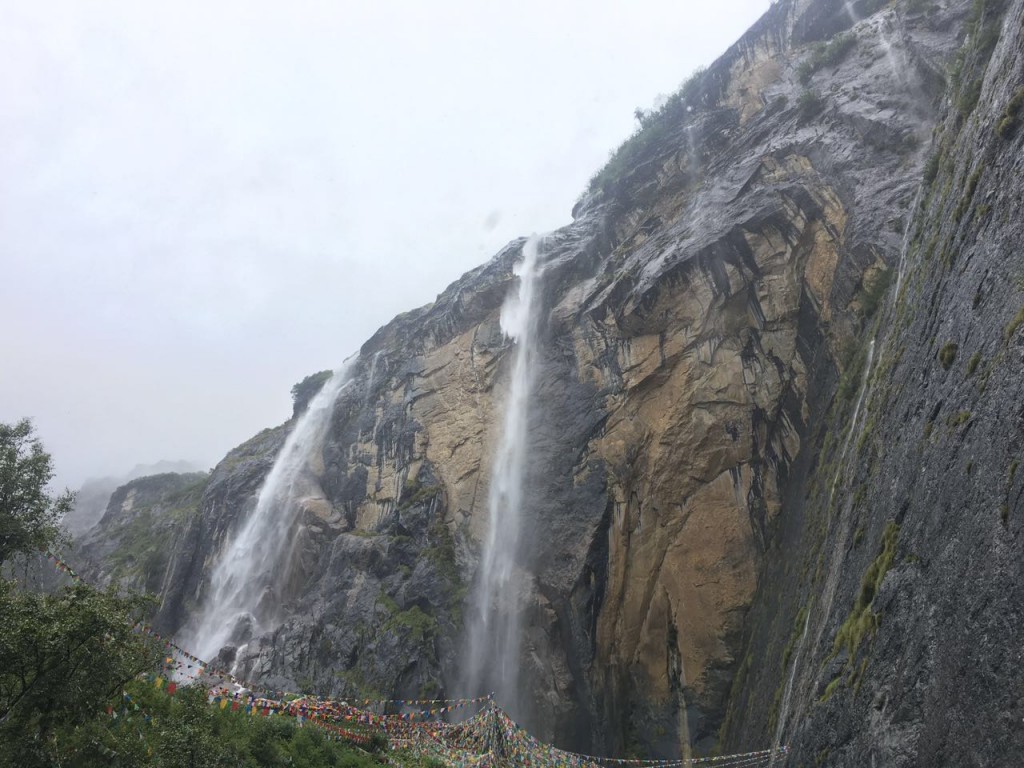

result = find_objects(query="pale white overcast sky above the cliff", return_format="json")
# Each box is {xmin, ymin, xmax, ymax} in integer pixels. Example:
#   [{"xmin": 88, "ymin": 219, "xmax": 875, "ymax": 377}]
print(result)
[{"xmin": 0, "ymin": 0, "xmax": 769, "ymax": 486}]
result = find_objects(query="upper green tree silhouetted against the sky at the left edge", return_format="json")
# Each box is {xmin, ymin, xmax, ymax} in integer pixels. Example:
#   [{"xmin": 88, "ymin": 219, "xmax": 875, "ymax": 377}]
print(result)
[{"xmin": 0, "ymin": 419, "xmax": 75, "ymax": 565}]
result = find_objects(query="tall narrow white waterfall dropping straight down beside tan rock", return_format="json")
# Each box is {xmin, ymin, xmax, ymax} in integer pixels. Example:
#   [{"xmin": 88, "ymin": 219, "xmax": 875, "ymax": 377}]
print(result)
[{"xmin": 464, "ymin": 236, "xmax": 540, "ymax": 714}]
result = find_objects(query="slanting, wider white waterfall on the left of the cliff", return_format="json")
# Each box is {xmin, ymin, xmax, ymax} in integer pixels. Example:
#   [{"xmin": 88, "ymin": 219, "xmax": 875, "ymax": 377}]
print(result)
[{"xmin": 190, "ymin": 357, "xmax": 355, "ymax": 658}]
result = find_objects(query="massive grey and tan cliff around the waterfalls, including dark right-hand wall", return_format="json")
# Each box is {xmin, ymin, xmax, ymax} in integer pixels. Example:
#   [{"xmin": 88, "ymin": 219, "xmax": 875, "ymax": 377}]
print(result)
[{"xmin": 77, "ymin": 0, "xmax": 1024, "ymax": 765}]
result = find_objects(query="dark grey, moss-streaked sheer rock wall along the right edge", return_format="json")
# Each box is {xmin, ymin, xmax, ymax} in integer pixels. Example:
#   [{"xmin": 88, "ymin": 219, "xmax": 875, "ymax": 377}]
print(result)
[{"xmin": 730, "ymin": 2, "xmax": 1024, "ymax": 766}]
